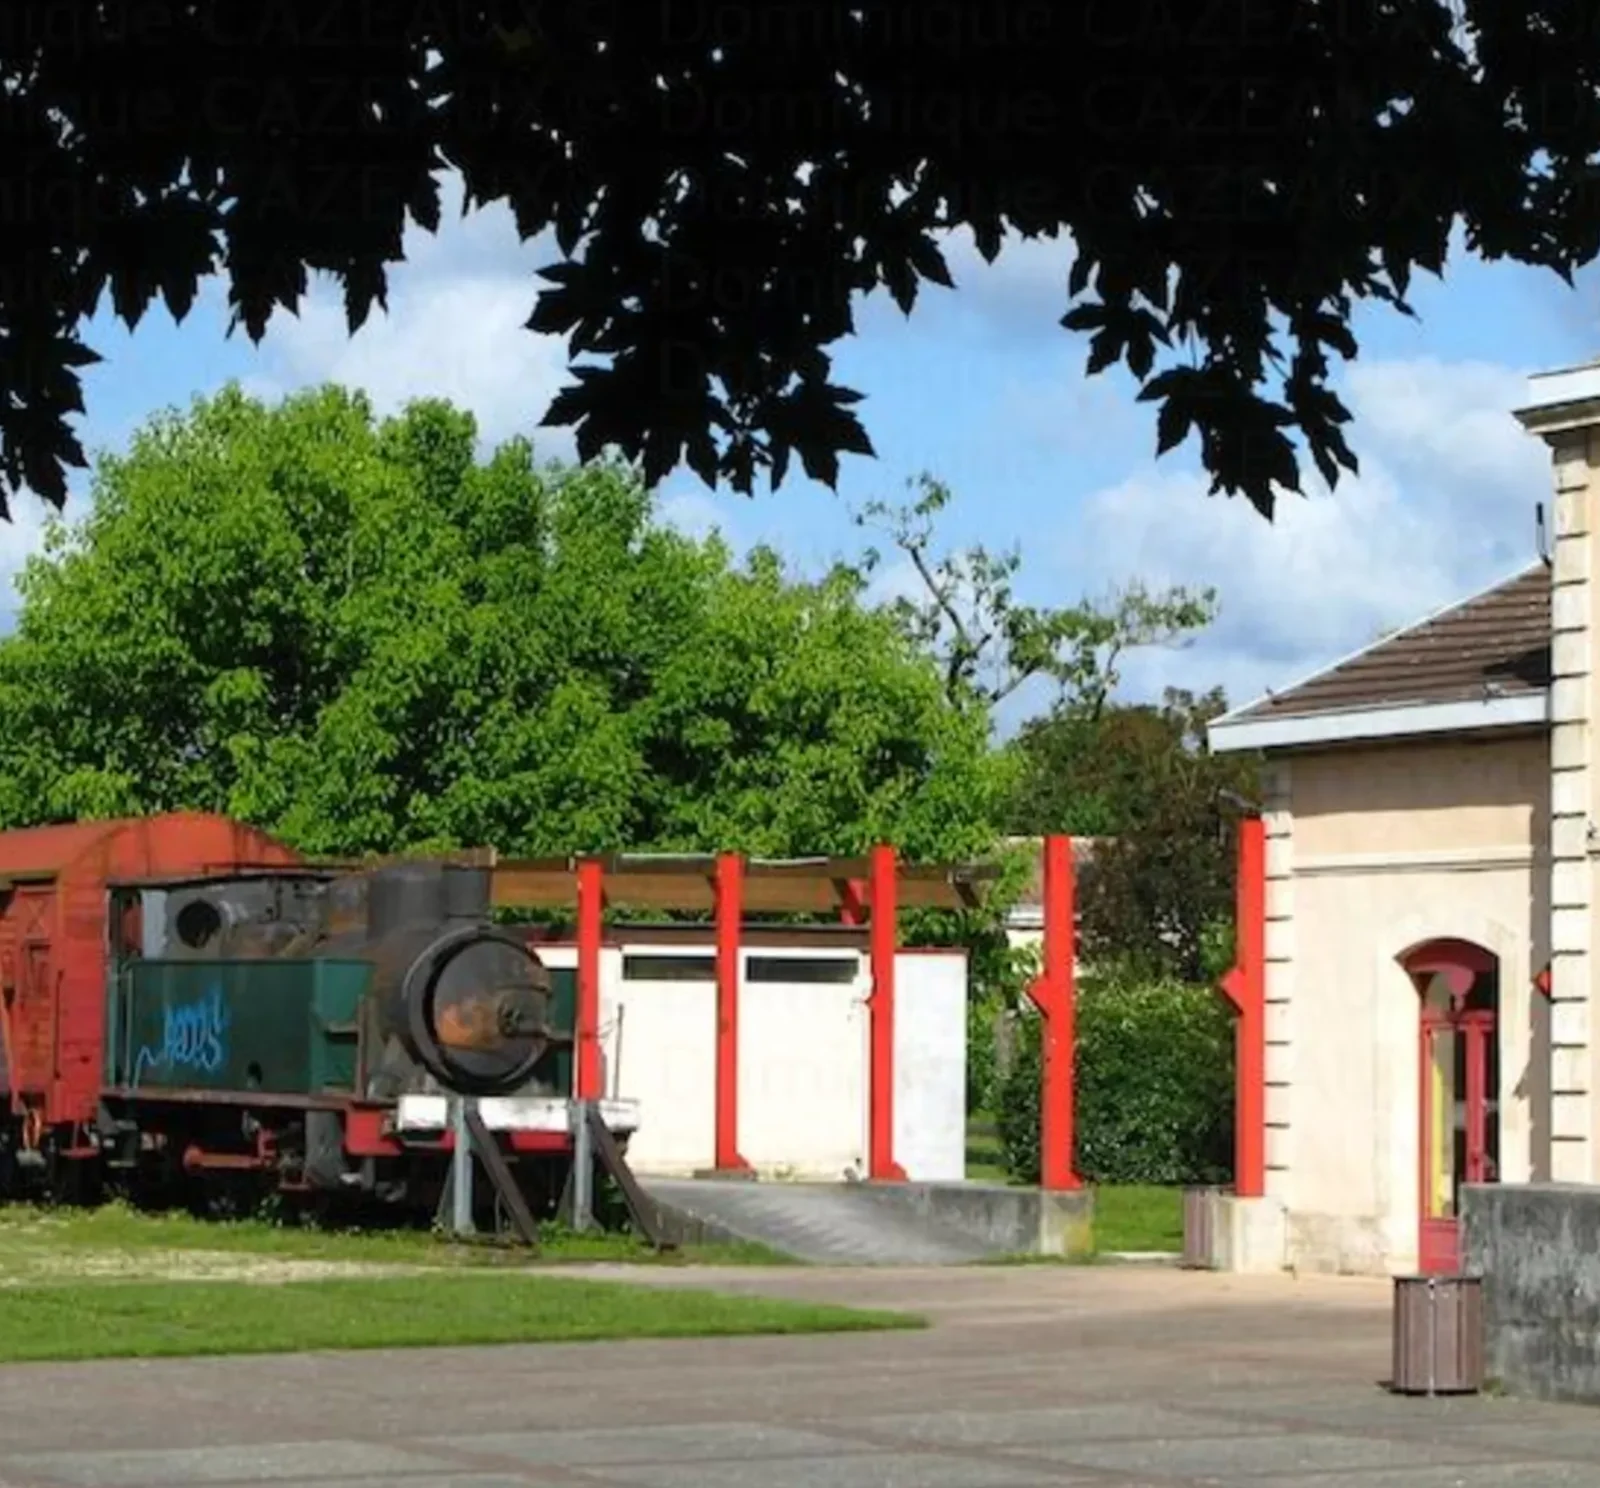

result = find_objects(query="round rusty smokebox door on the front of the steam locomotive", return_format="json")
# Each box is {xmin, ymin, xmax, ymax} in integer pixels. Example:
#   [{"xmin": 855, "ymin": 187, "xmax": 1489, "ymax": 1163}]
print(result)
[{"xmin": 403, "ymin": 925, "xmax": 552, "ymax": 1096}]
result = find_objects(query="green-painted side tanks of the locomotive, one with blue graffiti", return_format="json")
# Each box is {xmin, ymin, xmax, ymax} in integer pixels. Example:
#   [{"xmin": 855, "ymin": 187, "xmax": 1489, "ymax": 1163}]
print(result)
[{"xmin": 106, "ymin": 958, "xmax": 578, "ymax": 1096}]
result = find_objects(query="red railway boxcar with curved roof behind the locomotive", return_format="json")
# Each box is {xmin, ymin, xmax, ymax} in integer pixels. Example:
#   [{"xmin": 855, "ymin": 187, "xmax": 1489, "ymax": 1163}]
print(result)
[{"xmin": 0, "ymin": 811, "xmax": 299, "ymax": 1177}]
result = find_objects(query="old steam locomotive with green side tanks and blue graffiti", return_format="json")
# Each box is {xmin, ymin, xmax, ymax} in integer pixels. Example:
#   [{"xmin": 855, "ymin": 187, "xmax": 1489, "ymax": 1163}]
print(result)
[{"xmin": 0, "ymin": 861, "xmax": 574, "ymax": 1210}]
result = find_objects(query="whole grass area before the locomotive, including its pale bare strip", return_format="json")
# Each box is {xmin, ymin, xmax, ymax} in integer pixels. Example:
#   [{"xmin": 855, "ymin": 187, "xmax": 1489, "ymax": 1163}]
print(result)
[{"xmin": 0, "ymin": 1205, "xmax": 922, "ymax": 1363}]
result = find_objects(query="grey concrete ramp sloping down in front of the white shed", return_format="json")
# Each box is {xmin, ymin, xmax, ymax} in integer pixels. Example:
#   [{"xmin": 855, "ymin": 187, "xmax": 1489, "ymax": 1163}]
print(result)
[{"xmin": 638, "ymin": 1176, "xmax": 1078, "ymax": 1266}]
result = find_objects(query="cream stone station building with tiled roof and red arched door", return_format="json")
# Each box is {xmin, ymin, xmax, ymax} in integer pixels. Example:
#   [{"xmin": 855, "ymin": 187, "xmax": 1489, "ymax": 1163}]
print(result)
[{"xmin": 1211, "ymin": 363, "xmax": 1600, "ymax": 1274}]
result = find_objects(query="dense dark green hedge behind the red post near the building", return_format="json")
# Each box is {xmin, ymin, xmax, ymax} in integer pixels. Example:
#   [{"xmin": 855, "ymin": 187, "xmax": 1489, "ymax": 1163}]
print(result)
[{"xmin": 997, "ymin": 974, "xmax": 1234, "ymax": 1184}]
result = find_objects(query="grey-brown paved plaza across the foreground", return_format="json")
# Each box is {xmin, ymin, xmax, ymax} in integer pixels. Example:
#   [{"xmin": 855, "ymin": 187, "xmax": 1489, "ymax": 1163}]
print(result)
[{"xmin": 0, "ymin": 1266, "xmax": 1600, "ymax": 1488}]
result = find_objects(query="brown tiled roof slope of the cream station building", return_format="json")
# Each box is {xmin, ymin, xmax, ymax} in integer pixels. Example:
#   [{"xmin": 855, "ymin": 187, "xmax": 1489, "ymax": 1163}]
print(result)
[{"xmin": 1235, "ymin": 563, "xmax": 1550, "ymax": 720}]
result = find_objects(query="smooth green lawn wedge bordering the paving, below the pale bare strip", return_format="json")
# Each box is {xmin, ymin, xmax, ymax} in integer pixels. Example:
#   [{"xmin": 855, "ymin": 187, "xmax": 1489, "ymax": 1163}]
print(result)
[{"xmin": 0, "ymin": 1272, "xmax": 923, "ymax": 1363}]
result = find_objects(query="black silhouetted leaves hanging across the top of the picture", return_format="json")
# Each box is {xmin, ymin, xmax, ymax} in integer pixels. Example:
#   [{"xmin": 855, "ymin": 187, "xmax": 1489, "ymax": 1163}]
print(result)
[{"xmin": 0, "ymin": 0, "xmax": 1600, "ymax": 515}]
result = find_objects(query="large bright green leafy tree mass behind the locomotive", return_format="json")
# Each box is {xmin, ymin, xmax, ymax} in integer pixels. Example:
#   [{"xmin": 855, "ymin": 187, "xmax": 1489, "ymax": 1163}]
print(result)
[{"xmin": 0, "ymin": 387, "xmax": 1002, "ymax": 858}]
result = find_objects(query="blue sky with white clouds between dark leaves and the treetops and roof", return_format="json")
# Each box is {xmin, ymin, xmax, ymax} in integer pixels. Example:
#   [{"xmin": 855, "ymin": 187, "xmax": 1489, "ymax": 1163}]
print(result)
[{"xmin": 0, "ymin": 174, "xmax": 1600, "ymax": 726}]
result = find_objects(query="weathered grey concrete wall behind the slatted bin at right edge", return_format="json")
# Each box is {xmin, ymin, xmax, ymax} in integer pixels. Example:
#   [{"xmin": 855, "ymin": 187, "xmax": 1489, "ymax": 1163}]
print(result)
[{"xmin": 1461, "ymin": 1184, "xmax": 1600, "ymax": 1403}]
